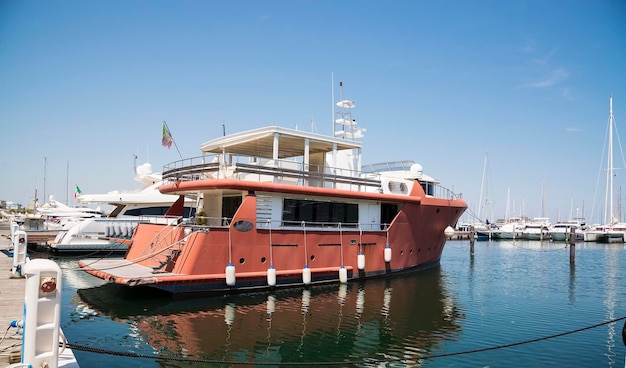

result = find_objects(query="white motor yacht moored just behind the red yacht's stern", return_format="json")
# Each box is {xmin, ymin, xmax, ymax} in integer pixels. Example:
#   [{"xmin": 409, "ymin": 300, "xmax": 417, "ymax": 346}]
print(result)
[{"xmin": 49, "ymin": 164, "xmax": 194, "ymax": 252}]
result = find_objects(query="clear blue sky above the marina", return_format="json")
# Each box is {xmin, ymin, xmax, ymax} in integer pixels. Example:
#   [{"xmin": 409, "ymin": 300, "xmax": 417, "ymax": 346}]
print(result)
[{"xmin": 0, "ymin": 0, "xmax": 626, "ymax": 223}]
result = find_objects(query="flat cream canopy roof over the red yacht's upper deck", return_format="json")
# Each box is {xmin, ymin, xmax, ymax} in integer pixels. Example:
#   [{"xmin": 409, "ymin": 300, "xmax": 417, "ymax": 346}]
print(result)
[{"xmin": 200, "ymin": 126, "xmax": 362, "ymax": 159}]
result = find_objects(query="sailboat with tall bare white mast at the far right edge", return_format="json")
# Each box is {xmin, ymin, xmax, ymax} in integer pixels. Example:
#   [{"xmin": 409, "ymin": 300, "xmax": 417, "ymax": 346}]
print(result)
[{"xmin": 585, "ymin": 97, "xmax": 626, "ymax": 243}]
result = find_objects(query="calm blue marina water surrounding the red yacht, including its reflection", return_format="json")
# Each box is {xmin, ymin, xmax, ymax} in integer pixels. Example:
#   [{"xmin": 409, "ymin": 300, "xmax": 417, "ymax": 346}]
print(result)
[{"xmin": 47, "ymin": 241, "xmax": 626, "ymax": 367}]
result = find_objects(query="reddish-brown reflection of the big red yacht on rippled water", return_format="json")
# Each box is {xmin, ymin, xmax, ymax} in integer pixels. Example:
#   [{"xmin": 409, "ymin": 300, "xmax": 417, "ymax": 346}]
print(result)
[{"xmin": 78, "ymin": 267, "xmax": 464, "ymax": 362}]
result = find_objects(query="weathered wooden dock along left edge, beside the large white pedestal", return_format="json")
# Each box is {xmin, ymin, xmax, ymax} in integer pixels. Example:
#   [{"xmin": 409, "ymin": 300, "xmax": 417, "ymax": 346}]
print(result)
[{"xmin": 0, "ymin": 221, "xmax": 78, "ymax": 368}]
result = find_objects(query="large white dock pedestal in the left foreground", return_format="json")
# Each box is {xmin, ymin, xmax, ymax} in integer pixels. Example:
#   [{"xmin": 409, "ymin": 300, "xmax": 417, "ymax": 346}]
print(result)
[{"xmin": 22, "ymin": 259, "xmax": 63, "ymax": 368}]
